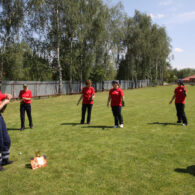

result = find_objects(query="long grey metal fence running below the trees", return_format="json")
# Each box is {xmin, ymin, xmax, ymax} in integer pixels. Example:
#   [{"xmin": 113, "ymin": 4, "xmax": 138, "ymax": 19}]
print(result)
[{"xmin": 1, "ymin": 80, "xmax": 152, "ymax": 98}]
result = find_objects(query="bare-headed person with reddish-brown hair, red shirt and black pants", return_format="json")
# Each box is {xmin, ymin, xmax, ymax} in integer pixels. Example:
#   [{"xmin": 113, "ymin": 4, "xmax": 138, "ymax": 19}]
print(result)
[{"xmin": 77, "ymin": 80, "xmax": 95, "ymax": 124}]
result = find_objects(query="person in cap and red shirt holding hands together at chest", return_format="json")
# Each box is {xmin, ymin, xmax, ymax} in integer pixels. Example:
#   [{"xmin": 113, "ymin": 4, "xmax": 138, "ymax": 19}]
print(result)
[{"xmin": 19, "ymin": 84, "xmax": 33, "ymax": 131}]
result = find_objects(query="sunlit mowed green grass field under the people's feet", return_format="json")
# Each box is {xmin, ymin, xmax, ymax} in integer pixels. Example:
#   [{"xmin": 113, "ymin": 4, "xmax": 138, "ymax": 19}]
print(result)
[{"xmin": 0, "ymin": 86, "xmax": 195, "ymax": 195}]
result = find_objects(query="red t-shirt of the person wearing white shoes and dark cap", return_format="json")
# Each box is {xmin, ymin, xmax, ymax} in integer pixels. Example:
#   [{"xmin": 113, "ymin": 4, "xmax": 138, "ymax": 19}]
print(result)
[{"xmin": 109, "ymin": 88, "xmax": 124, "ymax": 106}]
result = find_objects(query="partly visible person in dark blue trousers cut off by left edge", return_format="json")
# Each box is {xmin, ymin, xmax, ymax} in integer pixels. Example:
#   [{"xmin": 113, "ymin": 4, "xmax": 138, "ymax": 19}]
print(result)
[{"xmin": 0, "ymin": 92, "xmax": 13, "ymax": 171}]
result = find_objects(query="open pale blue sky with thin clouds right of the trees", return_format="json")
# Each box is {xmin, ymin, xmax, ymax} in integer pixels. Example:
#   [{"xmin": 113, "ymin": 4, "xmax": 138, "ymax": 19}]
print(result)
[{"xmin": 105, "ymin": 0, "xmax": 195, "ymax": 69}]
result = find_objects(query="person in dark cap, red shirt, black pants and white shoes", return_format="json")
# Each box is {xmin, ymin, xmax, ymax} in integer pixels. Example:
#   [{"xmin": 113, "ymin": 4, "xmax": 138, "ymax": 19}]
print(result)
[{"xmin": 107, "ymin": 81, "xmax": 124, "ymax": 128}]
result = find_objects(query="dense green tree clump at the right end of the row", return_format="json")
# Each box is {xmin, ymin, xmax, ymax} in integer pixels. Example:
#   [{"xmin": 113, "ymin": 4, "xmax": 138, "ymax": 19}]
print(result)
[{"xmin": 118, "ymin": 11, "xmax": 171, "ymax": 82}]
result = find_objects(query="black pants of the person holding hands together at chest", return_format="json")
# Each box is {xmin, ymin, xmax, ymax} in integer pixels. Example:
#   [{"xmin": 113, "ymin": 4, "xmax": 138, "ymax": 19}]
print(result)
[{"xmin": 20, "ymin": 103, "xmax": 33, "ymax": 128}]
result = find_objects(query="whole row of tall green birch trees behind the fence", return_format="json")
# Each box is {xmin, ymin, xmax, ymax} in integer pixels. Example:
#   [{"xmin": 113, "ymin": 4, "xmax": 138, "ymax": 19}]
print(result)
[{"xmin": 0, "ymin": 0, "xmax": 177, "ymax": 92}]
